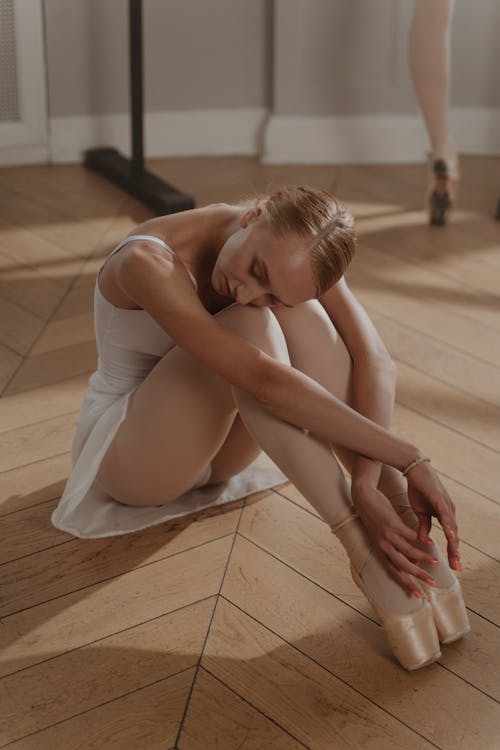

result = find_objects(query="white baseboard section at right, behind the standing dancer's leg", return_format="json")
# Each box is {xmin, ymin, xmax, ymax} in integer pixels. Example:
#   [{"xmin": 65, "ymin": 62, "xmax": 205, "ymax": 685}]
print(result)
[{"xmin": 261, "ymin": 109, "xmax": 500, "ymax": 164}]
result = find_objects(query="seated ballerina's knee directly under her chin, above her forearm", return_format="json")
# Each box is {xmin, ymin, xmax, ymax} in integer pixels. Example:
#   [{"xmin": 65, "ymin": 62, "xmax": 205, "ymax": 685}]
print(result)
[{"xmin": 216, "ymin": 304, "xmax": 290, "ymax": 364}]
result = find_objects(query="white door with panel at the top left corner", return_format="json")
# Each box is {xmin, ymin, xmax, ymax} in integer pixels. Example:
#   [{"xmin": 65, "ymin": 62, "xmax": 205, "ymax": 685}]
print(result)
[{"xmin": 0, "ymin": 0, "xmax": 48, "ymax": 165}]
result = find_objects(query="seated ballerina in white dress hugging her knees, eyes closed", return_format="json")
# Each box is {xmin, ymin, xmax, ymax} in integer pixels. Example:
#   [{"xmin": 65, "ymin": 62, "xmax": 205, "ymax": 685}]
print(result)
[{"xmin": 52, "ymin": 187, "xmax": 469, "ymax": 669}]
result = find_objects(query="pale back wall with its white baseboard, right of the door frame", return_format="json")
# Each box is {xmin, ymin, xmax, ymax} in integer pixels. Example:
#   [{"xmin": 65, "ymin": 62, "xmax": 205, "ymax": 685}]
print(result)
[{"xmin": 41, "ymin": 0, "xmax": 500, "ymax": 162}]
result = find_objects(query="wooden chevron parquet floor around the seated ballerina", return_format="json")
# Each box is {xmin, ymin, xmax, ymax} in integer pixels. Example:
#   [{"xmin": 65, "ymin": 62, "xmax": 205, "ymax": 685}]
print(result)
[{"xmin": 0, "ymin": 157, "xmax": 500, "ymax": 750}]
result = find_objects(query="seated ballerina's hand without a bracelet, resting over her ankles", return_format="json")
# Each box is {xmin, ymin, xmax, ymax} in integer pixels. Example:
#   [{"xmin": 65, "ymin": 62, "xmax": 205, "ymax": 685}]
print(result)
[{"xmin": 351, "ymin": 482, "xmax": 440, "ymax": 597}]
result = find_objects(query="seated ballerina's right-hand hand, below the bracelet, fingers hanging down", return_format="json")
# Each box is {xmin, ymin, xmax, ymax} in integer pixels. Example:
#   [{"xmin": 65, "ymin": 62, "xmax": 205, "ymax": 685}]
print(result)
[{"xmin": 406, "ymin": 461, "xmax": 460, "ymax": 568}]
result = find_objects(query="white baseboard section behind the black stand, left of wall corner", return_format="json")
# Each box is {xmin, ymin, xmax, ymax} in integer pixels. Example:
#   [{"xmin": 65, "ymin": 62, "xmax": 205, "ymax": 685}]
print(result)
[{"xmin": 49, "ymin": 109, "xmax": 266, "ymax": 163}]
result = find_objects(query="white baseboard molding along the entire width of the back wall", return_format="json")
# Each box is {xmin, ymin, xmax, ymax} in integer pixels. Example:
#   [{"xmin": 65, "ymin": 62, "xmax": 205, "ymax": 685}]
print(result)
[{"xmin": 0, "ymin": 109, "xmax": 500, "ymax": 165}]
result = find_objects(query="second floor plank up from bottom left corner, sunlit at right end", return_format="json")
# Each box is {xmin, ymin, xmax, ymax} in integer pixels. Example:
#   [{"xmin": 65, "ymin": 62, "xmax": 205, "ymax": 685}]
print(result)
[{"xmin": 0, "ymin": 592, "xmax": 215, "ymax": 743}]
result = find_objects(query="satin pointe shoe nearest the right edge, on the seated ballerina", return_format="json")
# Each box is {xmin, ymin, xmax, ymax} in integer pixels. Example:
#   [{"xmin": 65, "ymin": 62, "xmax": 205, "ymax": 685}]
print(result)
[{"xmin": 393, "ymin": 505, "xmax": 470, "ymax": 644}]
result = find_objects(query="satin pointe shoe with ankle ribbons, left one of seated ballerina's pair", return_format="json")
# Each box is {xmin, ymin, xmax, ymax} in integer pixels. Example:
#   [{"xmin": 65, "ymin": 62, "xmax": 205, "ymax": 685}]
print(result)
[{"xmin": 329, "ymin": 515, "xmax": 441, "ymax": 671}]
